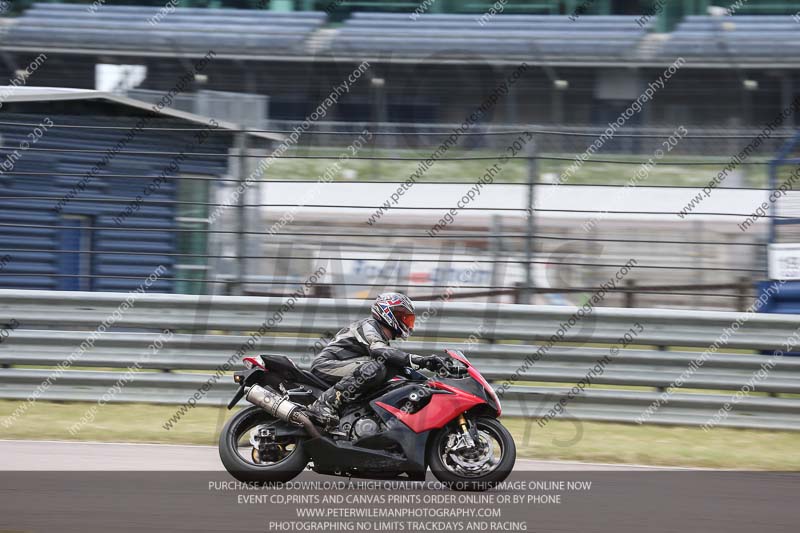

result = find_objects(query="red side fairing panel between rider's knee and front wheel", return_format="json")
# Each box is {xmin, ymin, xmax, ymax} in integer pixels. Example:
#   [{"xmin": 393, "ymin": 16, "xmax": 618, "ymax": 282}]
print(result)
[{"xmin": 375, "ymin": 381, "xmax": 486, "ymax": 433}]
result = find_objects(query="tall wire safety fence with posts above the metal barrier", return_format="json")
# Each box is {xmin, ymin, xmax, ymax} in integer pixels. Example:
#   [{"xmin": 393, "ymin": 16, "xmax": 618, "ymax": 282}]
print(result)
[{"xmin": 0, "ymin": 113, "xmax": 788, "ymax": 309}]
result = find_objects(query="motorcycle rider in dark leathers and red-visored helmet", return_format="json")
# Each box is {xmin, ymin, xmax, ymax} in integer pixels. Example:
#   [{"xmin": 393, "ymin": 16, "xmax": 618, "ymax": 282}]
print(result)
[{"xmin": 308, "ymin": 292, "xmax": 441, "ymax": 425}]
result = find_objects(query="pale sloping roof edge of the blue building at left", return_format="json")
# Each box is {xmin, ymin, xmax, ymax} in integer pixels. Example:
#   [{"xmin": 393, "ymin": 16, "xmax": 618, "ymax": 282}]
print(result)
[{"xmin": 0, "ymin": 85, "xmax": 284, "ymax": 141}]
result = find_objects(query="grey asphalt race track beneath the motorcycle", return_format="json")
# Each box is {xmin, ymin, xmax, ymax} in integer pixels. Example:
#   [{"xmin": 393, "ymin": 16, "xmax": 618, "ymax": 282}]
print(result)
[{"xmin": 0, "ymin": 441, "xmax": 800, "ymax": 533}]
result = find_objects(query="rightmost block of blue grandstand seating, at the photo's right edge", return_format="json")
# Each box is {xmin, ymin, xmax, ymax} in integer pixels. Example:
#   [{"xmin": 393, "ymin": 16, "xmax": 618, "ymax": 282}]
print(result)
[{"xmin": 661, "ymin": 15, "xmax": 800, "ymax": 60}]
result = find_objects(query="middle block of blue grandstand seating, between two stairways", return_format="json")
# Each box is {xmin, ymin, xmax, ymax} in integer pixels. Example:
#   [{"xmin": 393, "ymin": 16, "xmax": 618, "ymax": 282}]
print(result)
[{"xmin": 332, "ymin": 12, "xmax": 646, "ymax": 58}]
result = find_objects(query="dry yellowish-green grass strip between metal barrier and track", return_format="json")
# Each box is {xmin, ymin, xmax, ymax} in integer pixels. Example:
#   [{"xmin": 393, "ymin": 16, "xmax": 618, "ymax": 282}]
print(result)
[{"xmin": 0, "ymin": 401, "xmax": 800, "ymax": 471}]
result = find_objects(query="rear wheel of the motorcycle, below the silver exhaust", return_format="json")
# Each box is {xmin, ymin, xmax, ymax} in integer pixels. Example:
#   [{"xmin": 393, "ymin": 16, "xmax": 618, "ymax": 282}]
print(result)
[{"xmin": 219, "ymin": 406, "xmax": 308, "ymax": 483}]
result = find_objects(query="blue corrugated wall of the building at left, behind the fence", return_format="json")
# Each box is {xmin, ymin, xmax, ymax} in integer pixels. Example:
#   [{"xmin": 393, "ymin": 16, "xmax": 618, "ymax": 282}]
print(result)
[{"xmin": 0, "ymin": 103, "xmax": 231, "ymax": 292}]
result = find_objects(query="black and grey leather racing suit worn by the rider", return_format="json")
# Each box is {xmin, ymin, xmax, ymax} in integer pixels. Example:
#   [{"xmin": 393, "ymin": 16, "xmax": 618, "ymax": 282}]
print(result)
[{"xmin": 311, "ymin": 318, "xmax": 410, "ymax": 403}]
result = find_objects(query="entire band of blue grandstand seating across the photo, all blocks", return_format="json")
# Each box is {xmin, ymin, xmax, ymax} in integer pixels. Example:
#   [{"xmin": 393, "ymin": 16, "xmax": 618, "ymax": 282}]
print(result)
[{"xmin": 2, "ymin": 3, "xmax": 800, "ymax": 62}]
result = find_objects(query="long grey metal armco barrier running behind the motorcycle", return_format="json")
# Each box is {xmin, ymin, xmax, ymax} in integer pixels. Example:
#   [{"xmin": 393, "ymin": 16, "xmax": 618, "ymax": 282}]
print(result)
[{"xmin": 0, "ymin": 290, "xmax": 800, "ymax": 429}]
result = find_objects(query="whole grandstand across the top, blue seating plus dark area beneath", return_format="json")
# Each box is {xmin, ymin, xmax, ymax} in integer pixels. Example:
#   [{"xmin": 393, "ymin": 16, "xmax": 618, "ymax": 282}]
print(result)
[{"xmin": 0, "ymin": 0, "xmax": 800, "ymax": 127}]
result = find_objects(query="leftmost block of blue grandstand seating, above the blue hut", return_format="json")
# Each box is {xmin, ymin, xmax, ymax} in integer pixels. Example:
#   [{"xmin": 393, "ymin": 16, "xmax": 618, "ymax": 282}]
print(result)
[{"xmin": 4, "ymin": 4, "xmax": 326, "ymax": 54}]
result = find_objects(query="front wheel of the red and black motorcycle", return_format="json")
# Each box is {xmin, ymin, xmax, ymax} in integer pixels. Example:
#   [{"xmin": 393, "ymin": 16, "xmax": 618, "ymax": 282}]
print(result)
[{"xmin": 428, "ymin": 418, "xmax": 517, "ymax": 491}]
